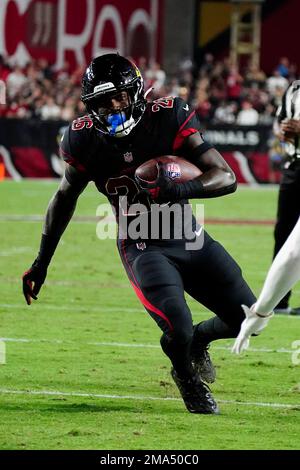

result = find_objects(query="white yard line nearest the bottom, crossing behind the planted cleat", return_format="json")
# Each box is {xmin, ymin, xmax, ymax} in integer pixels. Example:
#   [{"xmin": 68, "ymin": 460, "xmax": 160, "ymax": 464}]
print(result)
[{"xmin": 0, "ymin": 388, "xmax": 300, "ymax": 409}]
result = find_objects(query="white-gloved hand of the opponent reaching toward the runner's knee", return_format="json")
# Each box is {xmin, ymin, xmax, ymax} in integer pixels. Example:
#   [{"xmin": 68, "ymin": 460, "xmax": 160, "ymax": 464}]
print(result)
[{"xmin": 231, "ymin": 304, "xmax": 273, "ymax": 354}]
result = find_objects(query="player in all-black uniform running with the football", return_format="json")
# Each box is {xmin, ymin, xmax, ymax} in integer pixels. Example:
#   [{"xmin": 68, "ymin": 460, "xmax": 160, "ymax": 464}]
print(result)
[{"xmin": 23, "ymin": 54, "xmax": 255, "ymax": 414}]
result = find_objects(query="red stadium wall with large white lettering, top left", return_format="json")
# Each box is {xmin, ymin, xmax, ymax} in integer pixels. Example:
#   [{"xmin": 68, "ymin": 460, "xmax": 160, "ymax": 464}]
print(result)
[{"xmin": 0, "ymin": 0, "xmax": 164, "ymax": 69}]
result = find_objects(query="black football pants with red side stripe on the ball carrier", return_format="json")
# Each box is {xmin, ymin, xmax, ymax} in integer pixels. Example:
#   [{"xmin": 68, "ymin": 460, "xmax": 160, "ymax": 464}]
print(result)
[{"xmin": 118, "ymin": 233, "xmax": 256, "ymax": 376}]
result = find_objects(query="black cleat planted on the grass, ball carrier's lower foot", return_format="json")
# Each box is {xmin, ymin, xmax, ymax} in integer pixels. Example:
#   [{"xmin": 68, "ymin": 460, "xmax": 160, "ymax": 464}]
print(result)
[{"xmin": 171, "ymin": 368, "xmax": 220, "ymax": 414}]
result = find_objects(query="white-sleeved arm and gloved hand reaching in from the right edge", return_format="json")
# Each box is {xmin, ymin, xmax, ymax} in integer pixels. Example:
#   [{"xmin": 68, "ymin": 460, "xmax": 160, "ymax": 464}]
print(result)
[{"xmin": 232, "ymin": 218, "xmax": 300, "ymax": 354}]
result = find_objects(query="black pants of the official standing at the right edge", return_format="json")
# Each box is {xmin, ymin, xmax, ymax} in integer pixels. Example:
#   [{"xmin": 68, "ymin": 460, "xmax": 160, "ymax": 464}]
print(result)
[{"xmin": 274, "ymin": 162, "xmax": 300, "ymax": 308}]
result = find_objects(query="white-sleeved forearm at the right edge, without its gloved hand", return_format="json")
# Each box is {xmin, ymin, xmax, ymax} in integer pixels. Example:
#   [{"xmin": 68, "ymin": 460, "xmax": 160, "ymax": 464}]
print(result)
[{"xmin": 255, "ymin": 219, "xmax": 300, "ymax": 314}]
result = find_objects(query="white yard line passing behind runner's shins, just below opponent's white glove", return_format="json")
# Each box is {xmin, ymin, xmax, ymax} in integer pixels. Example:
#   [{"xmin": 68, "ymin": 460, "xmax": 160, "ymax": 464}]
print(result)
[{"xmin": 0, "ymin": 337, "xmax": 295, "ymax": 354}]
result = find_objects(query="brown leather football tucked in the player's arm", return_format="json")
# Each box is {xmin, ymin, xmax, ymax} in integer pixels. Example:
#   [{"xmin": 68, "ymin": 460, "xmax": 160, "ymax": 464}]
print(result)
[{"xmin": 135, "ymin": 155, "xmax": 202, "ymax": 183}]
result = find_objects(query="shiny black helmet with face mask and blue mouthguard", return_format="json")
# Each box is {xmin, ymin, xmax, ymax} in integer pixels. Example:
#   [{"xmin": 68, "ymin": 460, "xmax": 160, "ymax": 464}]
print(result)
[{"xmin": 81, "ymin": 54, "xmax": 146, "ymax": 137}]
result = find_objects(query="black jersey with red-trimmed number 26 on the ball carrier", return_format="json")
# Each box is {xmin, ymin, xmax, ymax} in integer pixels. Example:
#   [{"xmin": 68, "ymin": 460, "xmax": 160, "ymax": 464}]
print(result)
[{"xmin": 61, "ymin": 97, "xmax": 201, "ymax": 242}]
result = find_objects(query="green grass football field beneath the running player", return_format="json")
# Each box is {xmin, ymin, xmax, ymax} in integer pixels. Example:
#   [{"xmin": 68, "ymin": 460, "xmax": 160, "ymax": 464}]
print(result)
[{"xmin": 0, "ymin": 181, "xmax": 300, "ymax": 450}]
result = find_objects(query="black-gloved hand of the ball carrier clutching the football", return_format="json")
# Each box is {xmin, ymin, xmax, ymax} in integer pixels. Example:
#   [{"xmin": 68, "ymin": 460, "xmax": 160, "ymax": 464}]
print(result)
[{"xmin": 135, "ymin": 162, "xmax": 179, "ymax": 204}]
